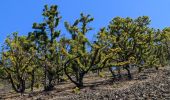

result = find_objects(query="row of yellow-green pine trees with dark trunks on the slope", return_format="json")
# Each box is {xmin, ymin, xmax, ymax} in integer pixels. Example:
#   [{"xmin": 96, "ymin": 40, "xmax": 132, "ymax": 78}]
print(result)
[{"xmin": 0, "ymin": 5, "xmax": 170, "ymax": 99}]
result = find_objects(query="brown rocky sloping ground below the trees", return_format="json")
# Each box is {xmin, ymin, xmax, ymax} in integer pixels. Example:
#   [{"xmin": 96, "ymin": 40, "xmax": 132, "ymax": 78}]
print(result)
[{"xmin": 1, "ymin": 67, "xmax": 170, "ymax": 100}]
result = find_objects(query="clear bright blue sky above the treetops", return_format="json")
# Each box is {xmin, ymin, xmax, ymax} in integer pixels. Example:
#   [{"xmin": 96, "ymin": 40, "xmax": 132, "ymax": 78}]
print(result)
[{"xmin": 0, "ymin": 0, "xmax": 170, "ymax": 44}]
